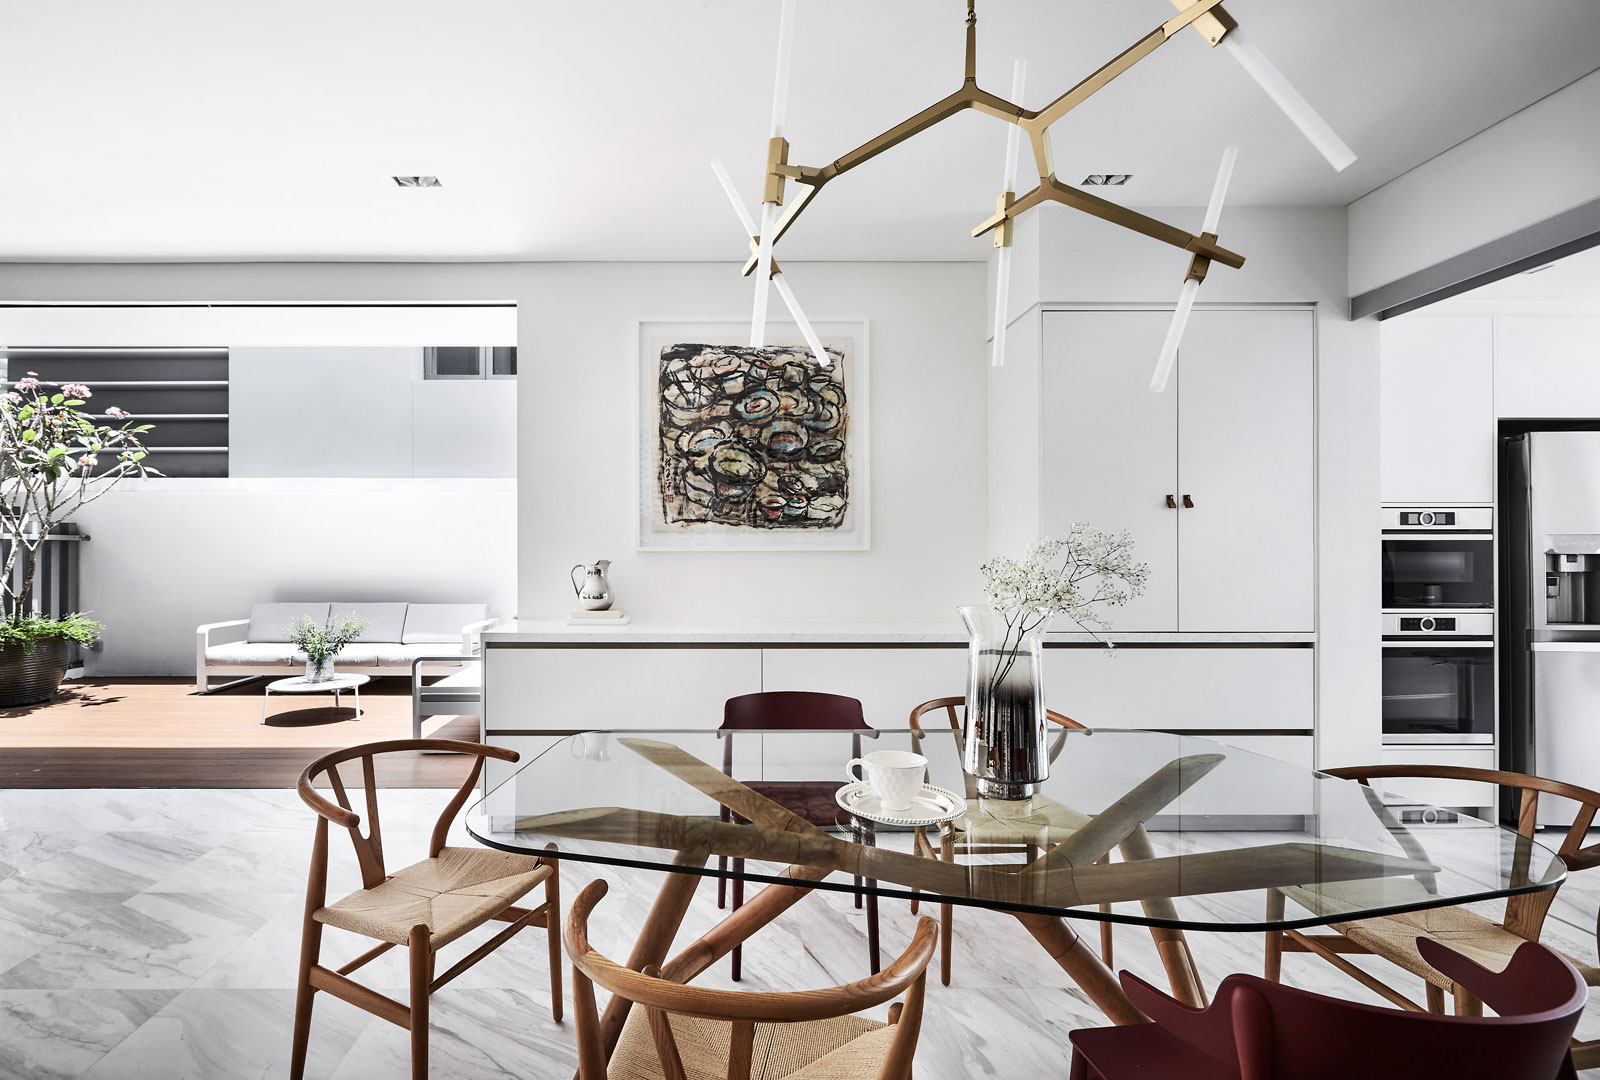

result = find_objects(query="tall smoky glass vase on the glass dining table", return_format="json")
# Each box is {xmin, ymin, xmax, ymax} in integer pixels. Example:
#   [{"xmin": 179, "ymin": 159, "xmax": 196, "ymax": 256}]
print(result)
[{"xmin": 960, "ymin": 606, "xmax": 1050, "ymax": 798}]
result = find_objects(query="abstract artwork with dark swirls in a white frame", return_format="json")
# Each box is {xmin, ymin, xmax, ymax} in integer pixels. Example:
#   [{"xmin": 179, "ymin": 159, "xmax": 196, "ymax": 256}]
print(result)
[{"xmin": 637, "ymin": 318, "xmax": 869, "ymax": 550}]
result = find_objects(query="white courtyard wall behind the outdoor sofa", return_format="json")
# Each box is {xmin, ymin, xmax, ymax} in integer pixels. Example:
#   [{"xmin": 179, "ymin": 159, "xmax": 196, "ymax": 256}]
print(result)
[{"xmin": 77, "ymin": 480, "xmax": 517, "ymax": 675}]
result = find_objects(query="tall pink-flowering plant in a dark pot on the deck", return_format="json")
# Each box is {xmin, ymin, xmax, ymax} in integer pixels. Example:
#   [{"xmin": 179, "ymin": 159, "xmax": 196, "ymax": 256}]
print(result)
[{"xmin": 0, "ymin": 368, "xmax": 160, "ymax": 709}]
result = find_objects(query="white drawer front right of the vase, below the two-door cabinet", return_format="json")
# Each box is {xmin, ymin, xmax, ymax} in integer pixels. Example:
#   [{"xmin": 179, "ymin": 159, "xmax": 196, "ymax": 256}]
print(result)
[{"xmin": 1045, "ymin": 646, "xmax": 1315, "ymax": 734}]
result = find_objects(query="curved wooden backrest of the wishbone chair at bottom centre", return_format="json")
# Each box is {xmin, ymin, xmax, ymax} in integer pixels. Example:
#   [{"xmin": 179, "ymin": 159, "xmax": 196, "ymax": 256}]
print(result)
[{"xmin": 562, "ymin": 878, "xmax": 939, "ymax": 1080}]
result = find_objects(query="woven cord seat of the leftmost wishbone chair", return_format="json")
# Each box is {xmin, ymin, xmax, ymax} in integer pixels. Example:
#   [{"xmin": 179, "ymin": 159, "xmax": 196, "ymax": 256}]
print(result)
[{"xmin": 312, "ymin": 848, "xmax": 550, "ymax": 949}]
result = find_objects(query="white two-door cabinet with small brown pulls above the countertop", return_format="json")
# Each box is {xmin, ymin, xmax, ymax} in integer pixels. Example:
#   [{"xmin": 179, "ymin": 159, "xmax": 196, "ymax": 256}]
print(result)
[{"xmin": 1040, "ymin": 307, "xmax": 1315, "ymax": 634}]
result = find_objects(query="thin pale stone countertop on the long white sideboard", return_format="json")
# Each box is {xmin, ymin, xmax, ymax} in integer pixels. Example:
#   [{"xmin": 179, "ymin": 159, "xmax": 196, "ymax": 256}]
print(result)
[{"xmin": 483, "ymin": 614, "xmax": 1317, "ymax": 648}]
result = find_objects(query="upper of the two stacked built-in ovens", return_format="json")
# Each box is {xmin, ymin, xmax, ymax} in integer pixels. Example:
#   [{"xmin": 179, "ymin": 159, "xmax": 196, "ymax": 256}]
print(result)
[{"xmin": 1382, "ymin": 507, "xmax": 1494, "ymax": 611}]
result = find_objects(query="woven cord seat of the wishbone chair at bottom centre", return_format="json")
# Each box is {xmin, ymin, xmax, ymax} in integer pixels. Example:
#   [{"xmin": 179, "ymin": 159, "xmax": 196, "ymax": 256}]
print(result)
[{"xmin": 606, "ymin": 1008, "xmax": 894, "ymax": 1080}]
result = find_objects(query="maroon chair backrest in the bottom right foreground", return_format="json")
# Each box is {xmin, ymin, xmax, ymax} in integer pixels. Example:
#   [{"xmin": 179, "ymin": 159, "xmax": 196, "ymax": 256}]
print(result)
[{"xmin": 1211, "ymin": 939, "xmax": 1587, "ymax": 1080}]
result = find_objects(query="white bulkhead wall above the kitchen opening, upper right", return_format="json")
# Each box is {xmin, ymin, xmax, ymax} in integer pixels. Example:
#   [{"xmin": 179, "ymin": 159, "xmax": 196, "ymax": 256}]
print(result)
[{"xmin": 1350, "ymin": 72, "xmax": 1600, "ymax": 296}]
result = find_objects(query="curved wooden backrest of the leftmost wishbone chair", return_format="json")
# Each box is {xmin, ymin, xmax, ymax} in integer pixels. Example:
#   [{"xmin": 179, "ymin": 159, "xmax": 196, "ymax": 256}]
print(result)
[{"xmin": 296, "ymin": 739, "xmax": 518, "ymax": 888}]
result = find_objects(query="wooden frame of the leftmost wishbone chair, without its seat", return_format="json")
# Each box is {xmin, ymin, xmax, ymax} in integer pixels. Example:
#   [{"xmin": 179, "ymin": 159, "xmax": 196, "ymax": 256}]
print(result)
[{"xmin": 290, "ymin": 739, "xmax": 562, "ymax": 1080}]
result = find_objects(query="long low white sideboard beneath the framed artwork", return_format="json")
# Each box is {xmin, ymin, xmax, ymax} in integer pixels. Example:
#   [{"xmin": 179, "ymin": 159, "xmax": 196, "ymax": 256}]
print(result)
[{"xmin": 483, "ymin": 624, "xmax": 1315, "ymax": 787}]
